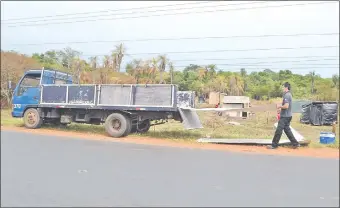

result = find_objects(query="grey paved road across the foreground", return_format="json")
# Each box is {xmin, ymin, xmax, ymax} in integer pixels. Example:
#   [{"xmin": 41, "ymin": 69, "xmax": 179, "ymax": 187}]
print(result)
[{"xmin": 1, "ymin": 131, "xmax": 339, "ymax": 207}]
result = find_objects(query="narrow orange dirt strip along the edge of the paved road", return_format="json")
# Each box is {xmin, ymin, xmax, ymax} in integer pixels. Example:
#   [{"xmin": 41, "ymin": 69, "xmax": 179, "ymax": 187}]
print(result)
[{"xmin": 1, "ymin": 126, "xmax": 339, "ymax": 158}]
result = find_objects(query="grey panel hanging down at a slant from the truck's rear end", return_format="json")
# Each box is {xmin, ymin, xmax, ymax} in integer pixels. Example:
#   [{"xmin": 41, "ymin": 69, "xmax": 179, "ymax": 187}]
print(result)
[{"xmin": 178, "ymin": 108, "xmax": 203, "ymax": 129}]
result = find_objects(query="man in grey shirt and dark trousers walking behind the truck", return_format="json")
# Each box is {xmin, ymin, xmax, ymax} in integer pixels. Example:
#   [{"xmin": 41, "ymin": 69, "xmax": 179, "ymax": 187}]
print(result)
[{"xmin": 268, "ymin": 82, "xmax": 300, "ymax": 149}]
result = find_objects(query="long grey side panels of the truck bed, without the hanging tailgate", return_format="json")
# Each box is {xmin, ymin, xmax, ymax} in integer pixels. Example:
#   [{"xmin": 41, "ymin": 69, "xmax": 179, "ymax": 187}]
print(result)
[{"xmin": 40, "ymin": 84, "xmax": 177, "ymax": 111}]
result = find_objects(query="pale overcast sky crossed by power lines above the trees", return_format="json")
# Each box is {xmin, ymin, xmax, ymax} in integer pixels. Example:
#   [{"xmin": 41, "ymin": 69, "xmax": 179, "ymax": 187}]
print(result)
[{"xmin": 1, "ymin": 1, "xmax": 339, "ymax": 77}]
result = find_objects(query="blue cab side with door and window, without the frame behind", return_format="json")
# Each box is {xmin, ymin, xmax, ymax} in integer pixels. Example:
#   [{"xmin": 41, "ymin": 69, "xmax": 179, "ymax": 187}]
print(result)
[{"xmin": 12, "ymin": 73, "xmax": 40, "ymax": 117}]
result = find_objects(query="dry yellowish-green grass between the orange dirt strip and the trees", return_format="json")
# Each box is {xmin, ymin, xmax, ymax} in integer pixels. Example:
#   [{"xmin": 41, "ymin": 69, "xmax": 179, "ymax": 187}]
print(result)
[{"xmin": 1, "ymin": 110, "xmax": 339, "ymax": 148}]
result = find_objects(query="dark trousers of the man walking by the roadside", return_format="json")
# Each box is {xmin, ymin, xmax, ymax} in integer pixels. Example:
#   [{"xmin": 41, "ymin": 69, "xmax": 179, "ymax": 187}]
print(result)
[{"xmin": 272, "ymin": 117, "xmax": 299, "ymax": 147}]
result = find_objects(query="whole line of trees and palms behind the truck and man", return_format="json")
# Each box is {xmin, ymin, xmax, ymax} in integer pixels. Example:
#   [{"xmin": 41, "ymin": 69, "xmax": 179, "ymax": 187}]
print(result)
[{"xmin": 1, "ymin": 48, "xmax": 339, "ymax": 107}]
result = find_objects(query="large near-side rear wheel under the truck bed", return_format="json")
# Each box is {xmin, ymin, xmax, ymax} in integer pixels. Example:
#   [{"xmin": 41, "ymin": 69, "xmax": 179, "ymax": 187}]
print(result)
[{"xmin": 105, "ymin": 113, "xmax": 131, "ymax": 138}]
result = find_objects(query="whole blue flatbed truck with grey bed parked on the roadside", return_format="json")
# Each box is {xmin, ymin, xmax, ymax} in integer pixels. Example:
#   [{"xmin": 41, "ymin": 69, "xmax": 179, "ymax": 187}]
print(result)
[{"xmin": 12, "ymin": 68, "xmax": 202, "ymax": 137}]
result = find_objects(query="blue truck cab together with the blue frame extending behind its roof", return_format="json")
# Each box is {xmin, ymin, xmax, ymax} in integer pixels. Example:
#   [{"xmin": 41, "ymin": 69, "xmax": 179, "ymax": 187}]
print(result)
[{"xmin": 12, "ymin": 69, "xmax": 72, "ymax": 118}]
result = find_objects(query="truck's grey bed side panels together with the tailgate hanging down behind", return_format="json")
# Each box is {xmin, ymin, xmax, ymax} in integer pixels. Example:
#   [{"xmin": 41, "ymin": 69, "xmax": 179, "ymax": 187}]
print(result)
[{"xmin": 39, "ymin": 84, "xmax": 203, "ymax": 129}]
